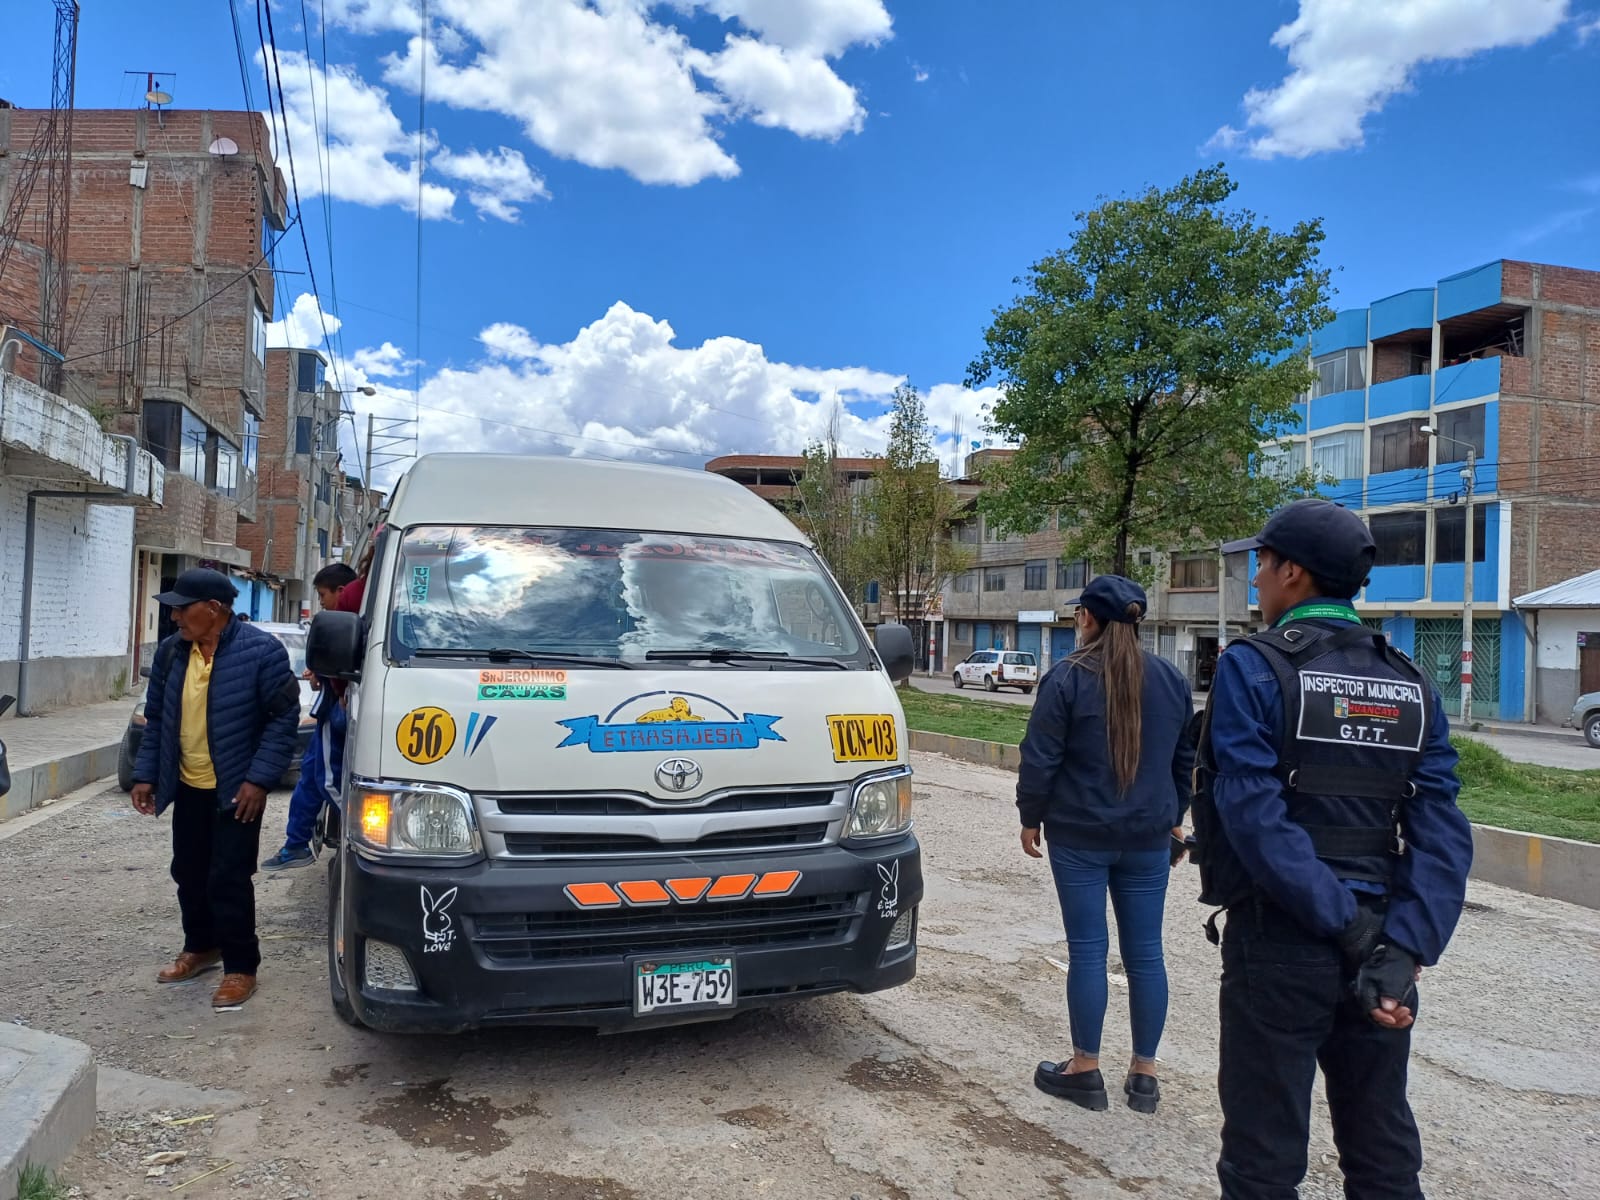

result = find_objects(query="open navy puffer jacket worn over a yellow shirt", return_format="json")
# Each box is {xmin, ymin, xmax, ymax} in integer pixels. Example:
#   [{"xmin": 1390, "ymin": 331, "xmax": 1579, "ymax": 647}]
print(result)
[{"xmin": 133, "ymin": 616, "xmax": 299, "ymax": 813}]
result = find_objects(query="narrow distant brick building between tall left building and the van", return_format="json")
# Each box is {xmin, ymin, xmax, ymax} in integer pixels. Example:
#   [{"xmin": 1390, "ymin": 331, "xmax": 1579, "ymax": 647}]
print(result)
[{"xmin": 238, "ymin": 349, "xmax": 346, "ymax": 621}]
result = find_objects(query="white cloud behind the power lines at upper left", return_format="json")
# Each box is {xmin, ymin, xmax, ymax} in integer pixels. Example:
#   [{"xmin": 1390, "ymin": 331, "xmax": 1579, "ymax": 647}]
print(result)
[{"xmin": 258, "ymin": 51, "xmax": 456, "ymax": 219}]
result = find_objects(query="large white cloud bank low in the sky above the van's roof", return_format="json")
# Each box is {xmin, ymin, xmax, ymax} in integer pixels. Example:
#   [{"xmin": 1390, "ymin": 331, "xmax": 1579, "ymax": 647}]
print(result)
[{"xmin": 307, "ymin": 302, "xmax": 997, "ymax": 483}]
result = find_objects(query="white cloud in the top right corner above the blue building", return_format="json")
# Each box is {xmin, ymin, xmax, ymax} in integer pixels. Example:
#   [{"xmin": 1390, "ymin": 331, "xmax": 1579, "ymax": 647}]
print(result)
[{"xmin": 1213, "ymin": 0, "xmax": 1570, "ymax": 158}]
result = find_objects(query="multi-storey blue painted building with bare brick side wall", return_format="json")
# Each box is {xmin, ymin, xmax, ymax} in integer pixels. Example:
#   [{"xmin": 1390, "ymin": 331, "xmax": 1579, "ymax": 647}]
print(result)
[{"xmin": 1250, "ymin": 261, "xmax": 1600, "ymax": 722}]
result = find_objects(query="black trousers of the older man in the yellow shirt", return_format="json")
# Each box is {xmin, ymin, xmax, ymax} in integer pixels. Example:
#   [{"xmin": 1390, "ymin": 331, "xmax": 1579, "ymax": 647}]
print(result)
[{"xmin": 173, "ymin": 784, "xmax": 261, "ymax": 974}]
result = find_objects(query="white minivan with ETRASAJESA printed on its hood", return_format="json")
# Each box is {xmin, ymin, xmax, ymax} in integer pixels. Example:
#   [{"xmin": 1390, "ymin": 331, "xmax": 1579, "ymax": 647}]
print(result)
[{"xmin": 307, "ymin": 454, "xmax": 923, "ymax": 1030}]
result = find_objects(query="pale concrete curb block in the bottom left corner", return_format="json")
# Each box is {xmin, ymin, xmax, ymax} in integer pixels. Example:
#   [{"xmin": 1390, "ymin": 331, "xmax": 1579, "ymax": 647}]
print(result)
[{"xmin": 0, "ymin": 1024, "xmax": 96, "ymax": 1195}]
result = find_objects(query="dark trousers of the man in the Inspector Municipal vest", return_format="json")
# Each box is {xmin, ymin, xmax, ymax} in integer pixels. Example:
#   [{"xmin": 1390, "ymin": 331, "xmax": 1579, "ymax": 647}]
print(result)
[{"xmin": 1216, "ymin": 904, "xmax": 1422, "ymax": 1200}]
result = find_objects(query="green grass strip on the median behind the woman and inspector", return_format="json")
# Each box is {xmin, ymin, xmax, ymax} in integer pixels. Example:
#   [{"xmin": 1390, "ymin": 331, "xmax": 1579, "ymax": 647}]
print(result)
[{"xmin": 899, "ymin": 688, "xmax": 1600, "ymax": 843}]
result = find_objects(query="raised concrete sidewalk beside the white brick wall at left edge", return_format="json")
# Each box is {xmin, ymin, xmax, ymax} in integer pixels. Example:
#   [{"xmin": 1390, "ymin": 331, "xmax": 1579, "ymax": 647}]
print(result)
[{"xmin": 0, "ymin": 696, "xmax": 136, "ymax": 821}]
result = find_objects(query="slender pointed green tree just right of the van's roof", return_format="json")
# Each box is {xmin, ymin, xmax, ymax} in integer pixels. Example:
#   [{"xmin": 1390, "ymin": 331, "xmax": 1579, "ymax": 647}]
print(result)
[{"xmin": 862, "ymin": 386, "xmax": 971, "ymax": 621}]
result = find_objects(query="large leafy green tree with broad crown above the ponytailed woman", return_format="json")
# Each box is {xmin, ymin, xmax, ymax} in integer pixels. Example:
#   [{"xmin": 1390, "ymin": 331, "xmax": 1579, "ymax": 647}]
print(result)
[{"xmin": 966, "ymin": 165, "xmax": 1333, "ymax": 574}]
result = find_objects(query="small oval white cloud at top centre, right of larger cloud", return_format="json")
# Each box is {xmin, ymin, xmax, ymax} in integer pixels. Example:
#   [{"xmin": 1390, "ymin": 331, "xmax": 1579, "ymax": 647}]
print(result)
[{"xmin": 699, "ymin": 37, "xmax": 867, "ymax": 138}]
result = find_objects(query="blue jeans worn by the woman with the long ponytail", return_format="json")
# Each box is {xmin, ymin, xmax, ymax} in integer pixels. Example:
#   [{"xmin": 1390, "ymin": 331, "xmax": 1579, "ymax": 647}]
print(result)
[{"xmin": 1050, "ymin": 843, "xmax": 1171, "ymax": 1059}]
